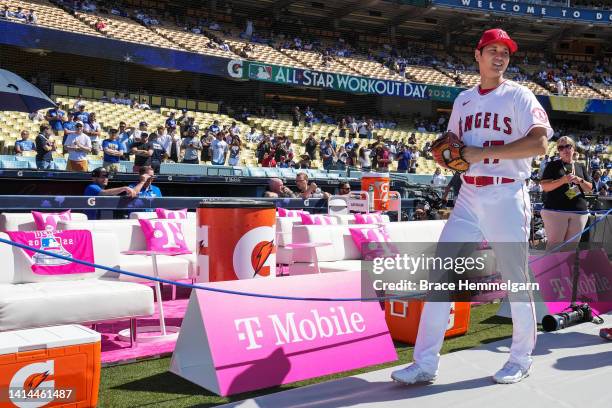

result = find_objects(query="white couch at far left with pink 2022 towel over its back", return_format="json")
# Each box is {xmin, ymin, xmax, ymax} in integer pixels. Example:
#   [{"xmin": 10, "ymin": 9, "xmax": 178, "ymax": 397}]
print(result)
[{"xmin": 0, "ymin": 231, "xmax": 154, "ymax": 331}]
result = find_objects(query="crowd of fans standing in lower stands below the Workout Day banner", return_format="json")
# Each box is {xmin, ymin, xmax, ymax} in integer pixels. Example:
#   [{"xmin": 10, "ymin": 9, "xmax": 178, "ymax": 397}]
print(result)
[{"xmin": 5, "ymin": 89, "xmax": 612, "ymax": 196}]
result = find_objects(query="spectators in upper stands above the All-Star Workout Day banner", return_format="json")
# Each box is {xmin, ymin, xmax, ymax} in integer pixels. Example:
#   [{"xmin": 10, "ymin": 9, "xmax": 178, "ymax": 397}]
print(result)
[{"xmin": 8, "ymin": 0, "xmax": 612, "ymax": 96}]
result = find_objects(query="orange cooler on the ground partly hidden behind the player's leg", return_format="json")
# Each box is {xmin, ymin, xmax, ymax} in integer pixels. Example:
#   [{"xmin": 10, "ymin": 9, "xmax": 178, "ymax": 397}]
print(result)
[{"xmin": 385, "ymin": 300, "xmax": 470, "ymax": 344}]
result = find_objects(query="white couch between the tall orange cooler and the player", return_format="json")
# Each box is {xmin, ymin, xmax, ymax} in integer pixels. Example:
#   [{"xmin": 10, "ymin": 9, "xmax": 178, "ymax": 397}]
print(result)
[{"xmin": 289, "ymin": 220, "xmax": 446, "ymax": 275}]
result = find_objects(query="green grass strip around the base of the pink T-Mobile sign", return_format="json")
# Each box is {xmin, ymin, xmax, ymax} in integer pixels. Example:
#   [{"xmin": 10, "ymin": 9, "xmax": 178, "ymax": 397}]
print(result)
[{"xmin": 98, "ymin": 304, "xmax": 512, "ymax": 408}]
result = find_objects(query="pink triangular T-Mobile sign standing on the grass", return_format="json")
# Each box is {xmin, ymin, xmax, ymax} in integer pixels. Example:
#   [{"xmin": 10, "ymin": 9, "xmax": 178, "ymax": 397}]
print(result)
[{"xmin": 171, "ymin": 272, "xmax": 397, "ymax": 396}]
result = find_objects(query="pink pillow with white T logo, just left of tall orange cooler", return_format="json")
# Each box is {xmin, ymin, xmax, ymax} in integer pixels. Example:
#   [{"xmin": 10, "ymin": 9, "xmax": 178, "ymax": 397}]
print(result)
[{"xmin": 138, "ymin": 219, "xmax": 191, "ymax": 254}]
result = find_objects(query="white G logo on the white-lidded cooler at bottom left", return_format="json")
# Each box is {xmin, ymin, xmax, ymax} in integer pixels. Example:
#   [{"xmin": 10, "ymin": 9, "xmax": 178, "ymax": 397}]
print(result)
[{"xmin": 9, "ymin": 360, "xmax": 55, "ymax": 408}]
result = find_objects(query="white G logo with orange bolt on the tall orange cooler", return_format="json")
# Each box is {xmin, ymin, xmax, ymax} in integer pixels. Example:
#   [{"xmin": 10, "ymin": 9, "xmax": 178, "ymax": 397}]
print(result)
[{"xmin": 232, "ymin": 226, "xmax": 276, "ymax": 279}]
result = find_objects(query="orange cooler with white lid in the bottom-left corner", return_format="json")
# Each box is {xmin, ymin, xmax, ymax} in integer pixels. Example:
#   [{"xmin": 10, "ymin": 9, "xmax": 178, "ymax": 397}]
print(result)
[{"xmin": 0, "ymin": 325, "xmax": 101, "ymax": 408}]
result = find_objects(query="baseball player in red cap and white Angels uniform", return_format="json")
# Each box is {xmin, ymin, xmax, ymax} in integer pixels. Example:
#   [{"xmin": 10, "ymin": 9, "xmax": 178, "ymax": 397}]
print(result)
[{"xmin": 391, "ymin": 29, "xmax": 553, "ymax": 384}]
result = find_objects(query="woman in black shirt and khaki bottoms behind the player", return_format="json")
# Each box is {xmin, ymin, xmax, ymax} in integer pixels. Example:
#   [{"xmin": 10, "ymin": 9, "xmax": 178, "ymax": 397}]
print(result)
[{"xmin": 541, "ymin": 136, "xmax": 593, "ymax": 251}]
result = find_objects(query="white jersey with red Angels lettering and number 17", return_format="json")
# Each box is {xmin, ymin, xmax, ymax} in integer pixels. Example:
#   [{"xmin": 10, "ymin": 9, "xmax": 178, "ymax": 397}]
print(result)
[{"xmin": 448, "ymin": 80, "xmax": 553, "ymax": 179}]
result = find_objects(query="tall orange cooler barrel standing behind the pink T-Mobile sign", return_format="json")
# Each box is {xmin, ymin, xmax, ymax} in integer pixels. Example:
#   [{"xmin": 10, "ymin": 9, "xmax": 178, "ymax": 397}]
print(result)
[{"xmin": 197, "ymin": 199, "xmax": 276, "ymax": 282}]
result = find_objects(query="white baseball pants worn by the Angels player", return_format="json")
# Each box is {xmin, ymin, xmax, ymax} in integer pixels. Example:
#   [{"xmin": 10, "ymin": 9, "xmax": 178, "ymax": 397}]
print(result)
[{"xmin": 414, "ymin": 181, "xmax": 537, "ymax": 373}]
